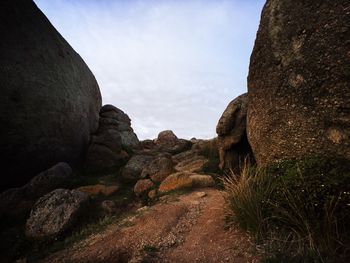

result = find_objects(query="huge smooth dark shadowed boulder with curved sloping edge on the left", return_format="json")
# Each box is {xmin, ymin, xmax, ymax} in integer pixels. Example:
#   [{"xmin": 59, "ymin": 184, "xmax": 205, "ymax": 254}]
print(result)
[{"xmin": 0, "ymin": 0, "xmax": 101, "ymax": 191}]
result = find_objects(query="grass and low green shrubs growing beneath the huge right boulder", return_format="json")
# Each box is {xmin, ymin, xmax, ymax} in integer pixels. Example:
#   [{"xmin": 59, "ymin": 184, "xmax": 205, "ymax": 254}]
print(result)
[{"xmin": 224, "ymin": 157, "xmax": 350, "ymax": 262}]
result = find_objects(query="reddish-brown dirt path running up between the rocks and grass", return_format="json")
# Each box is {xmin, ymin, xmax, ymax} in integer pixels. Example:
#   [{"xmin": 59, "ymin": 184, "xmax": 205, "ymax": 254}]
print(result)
[{"xmin": 44, "ymin": 189, "xmax": 258, "ymax": 263}]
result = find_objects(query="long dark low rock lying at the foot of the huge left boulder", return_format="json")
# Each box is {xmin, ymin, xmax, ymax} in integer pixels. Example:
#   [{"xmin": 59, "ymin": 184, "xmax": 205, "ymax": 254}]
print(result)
[{"xmin": 0, "ymin": 163, "xmax": 73, "ymax": 218}]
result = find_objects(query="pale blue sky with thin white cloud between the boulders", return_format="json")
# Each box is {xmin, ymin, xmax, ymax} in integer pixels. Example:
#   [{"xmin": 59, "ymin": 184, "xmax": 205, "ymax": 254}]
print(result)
[{"xmin": 34, "ymin": 0, "xmax": 265, "ymax": 139}]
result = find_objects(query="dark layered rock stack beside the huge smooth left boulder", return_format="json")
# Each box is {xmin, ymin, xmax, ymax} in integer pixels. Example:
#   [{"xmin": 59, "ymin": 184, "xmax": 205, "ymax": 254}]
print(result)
[{"xmin": 86, "ymin": 104, "xmax": 139, "ymax": 170}]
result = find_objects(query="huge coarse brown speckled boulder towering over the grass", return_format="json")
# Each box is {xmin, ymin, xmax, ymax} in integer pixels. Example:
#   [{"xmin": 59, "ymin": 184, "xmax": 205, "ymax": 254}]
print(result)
[{"xmin": 248, "ymin": 0, "xmax": 350, "ymax": 165}]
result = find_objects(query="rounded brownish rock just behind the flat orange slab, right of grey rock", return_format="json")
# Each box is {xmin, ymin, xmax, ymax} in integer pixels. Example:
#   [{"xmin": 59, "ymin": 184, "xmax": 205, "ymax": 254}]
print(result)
[{"xmin": 141, "ymin": 156, "xmax": 174, "ymax": 182}]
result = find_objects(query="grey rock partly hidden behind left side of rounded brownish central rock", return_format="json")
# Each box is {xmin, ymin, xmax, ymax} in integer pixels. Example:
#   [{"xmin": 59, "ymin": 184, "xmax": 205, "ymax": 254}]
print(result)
[{"xmin": 122, "ymin": 155, "xmax": 155, "ymax": 180}]
